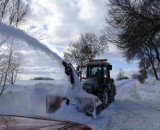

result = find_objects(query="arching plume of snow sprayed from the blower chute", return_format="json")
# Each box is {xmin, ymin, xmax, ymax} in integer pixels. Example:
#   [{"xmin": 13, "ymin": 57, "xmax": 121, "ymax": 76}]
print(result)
[{"xmin": 0, "ymin": 22, "xmax": 63, "ymax": 67}]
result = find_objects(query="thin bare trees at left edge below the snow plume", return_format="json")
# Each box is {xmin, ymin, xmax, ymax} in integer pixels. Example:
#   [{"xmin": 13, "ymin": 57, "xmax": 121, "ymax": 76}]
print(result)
[{"xmin": 0, "ymin": 43, "xmax": 22, "ymax": 95}]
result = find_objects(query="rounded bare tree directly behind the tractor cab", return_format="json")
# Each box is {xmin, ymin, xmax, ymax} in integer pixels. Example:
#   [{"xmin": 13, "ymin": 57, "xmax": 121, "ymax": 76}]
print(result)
[{"xmin": 64, "ymin": 33, "xmax": 108, "ymax": 66}]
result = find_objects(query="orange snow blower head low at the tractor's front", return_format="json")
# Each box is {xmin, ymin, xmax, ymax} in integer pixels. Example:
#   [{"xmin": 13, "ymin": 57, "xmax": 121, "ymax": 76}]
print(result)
[{"xmin": 46, "ymin": 95, "xmax": 102, "ymax": 117}]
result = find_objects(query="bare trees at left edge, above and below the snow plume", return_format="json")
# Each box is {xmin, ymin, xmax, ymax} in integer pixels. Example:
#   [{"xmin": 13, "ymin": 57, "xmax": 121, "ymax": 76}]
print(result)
[{"xmin": 0, "ymin": 0, "xmax": 30, "ymax": 96}]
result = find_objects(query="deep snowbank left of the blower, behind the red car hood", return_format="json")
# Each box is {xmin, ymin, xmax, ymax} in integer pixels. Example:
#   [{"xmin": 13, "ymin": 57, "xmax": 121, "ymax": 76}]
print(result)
[{"xmin": 0, "ymin": 80, "xmax": 70, "ymax": 116}]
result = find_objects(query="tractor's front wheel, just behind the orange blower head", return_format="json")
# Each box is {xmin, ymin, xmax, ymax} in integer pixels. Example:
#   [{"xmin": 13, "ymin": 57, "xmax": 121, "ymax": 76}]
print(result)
[{"xmin": 102, "ymin": 90, "xmax": 110, "ymax": 109}]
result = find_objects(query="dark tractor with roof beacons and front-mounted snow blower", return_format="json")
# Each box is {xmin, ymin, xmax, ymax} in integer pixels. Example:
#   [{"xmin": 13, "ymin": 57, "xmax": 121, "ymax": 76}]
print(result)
[{"xmin": 46, "ymin": 59, "xmax": 116, "ymax": 117}]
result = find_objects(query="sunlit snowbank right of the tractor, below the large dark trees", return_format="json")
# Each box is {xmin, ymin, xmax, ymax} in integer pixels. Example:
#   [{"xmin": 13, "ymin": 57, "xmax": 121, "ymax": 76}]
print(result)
[{"xmin": 115, "ymin": 80, "xmax": 160, "ymax": 103}]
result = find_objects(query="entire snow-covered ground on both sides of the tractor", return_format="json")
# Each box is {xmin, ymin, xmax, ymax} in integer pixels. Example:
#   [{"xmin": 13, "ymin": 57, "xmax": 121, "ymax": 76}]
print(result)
[{"xmin": 0, "ymin": 80, "xmax": 160, "ymax": 130}]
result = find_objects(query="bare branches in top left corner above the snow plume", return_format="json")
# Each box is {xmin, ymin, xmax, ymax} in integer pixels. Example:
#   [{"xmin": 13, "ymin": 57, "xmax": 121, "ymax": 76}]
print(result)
[{"xmin": 0, "ymin": 0, "xmax": 30, "ymax": 27}]
